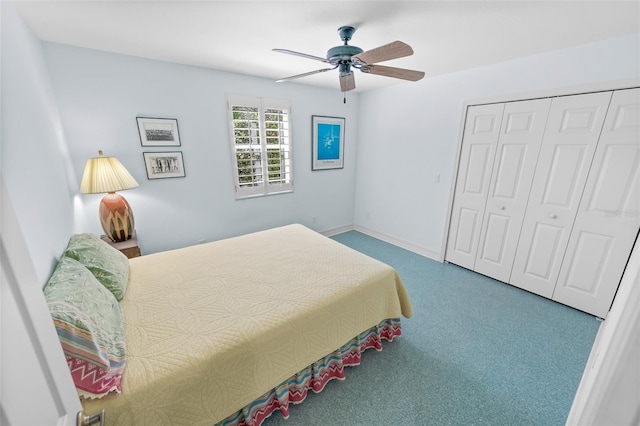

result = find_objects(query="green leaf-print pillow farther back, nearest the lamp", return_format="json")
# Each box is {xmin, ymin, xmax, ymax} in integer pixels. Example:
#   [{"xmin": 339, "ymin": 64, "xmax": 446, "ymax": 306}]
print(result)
[{"xmin": 63, "ymin": 233, "xmax": 129, "ymax": 301}]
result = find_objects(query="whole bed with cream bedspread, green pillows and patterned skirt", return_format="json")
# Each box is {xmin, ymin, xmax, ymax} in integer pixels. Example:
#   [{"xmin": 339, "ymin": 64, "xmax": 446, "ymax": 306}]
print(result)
[{"xmin": 45, "ymin": 224, "xmax": 412, "ymax": 425}]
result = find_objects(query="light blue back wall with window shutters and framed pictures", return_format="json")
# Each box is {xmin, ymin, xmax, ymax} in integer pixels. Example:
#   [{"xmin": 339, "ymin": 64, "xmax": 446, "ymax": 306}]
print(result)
[{"xmin": 44, "ymin": 43, "xmax": 359, "ymax": 253}]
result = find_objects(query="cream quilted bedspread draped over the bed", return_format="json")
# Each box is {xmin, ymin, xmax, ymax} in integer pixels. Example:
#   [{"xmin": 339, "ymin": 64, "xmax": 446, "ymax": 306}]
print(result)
[{"xmin": 83, "ymin": 225, "xmax": 412, "ymax": 426}]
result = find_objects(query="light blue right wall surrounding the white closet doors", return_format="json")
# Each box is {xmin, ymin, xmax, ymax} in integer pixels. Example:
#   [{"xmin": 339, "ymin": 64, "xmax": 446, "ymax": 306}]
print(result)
[{"xmin": 354, "ymin": 34, "xmax": 640, "ymax": 258}]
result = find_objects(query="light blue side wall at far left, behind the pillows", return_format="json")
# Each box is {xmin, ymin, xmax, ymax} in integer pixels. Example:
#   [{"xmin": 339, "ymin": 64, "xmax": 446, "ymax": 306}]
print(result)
[{"xmin": 0, "ymin": 1, "xmax": 78, "ymax": 286}]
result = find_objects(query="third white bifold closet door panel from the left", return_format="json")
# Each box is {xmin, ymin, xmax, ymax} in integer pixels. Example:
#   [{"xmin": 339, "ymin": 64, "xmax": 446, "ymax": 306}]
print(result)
[{"xmin": 509, "ymin": 92, "xmax": 611, "ymax": 298}]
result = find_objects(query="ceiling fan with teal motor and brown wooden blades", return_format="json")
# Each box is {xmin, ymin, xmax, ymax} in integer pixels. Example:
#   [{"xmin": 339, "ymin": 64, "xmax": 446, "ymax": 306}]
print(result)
[{"xmin": 273, "ymin": 26, "xmax": 424, "ymax": 92}]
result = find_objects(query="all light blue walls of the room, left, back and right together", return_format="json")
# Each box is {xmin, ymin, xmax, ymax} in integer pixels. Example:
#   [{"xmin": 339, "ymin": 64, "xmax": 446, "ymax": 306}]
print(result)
[{"xmin": 2, "ymin": 2, "xmax": 640, "ymax": 268}]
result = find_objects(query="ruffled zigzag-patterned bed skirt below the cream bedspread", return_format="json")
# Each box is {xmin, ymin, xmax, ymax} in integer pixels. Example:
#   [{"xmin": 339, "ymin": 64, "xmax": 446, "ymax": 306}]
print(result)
[{"xmin": 217, "ymin": 318, "xmax": 402, "ymax": 426}]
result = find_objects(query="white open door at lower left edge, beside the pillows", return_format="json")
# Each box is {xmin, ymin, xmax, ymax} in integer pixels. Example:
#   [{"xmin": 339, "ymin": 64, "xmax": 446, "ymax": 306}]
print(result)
[{"xmin": 0, "ymin": 176, "xmax": 82, "ymax": 426}]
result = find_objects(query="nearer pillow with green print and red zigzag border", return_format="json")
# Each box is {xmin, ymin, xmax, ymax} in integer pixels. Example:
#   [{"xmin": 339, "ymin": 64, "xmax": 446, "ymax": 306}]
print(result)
[{"xmin": 43, "ymin": 256, "xmax": 126, "ymax": 398}]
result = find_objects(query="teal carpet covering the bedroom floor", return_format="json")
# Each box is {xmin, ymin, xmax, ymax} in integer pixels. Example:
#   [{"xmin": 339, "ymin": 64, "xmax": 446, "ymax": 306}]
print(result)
[{"xmin": 264, "ymin": 231, "xmax": 600, "ymax": 426}]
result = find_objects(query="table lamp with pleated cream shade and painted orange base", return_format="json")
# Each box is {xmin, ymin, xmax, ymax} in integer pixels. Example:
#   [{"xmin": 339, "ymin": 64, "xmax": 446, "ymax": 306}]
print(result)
[{"xmin": 80, "ymin": 151, "xmax": 138, "ymax": 242}]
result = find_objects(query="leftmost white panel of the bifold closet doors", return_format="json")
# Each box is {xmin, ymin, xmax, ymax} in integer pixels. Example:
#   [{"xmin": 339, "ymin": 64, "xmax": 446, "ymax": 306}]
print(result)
[{"xmin": 445, "ymin": 104, "xmax": 504, "ymax": 269}]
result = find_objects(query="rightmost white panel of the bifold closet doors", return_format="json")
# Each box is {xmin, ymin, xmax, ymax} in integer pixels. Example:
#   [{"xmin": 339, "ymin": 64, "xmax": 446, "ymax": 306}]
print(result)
[{"xmin": 553, "ymin": 89, "xmax": 640, "ymax": 318}]
